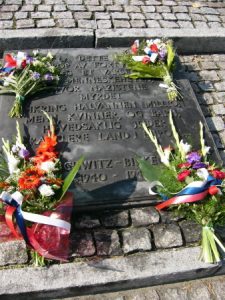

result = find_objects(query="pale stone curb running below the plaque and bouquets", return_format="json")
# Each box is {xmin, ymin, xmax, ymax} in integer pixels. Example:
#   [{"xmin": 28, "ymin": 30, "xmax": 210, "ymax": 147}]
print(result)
[{"xmin": 0, "ymin": 247, "xmax": 224, "ymax": 299}]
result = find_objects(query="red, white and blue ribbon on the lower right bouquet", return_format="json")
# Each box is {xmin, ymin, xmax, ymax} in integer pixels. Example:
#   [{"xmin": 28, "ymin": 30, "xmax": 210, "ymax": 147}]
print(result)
[{"xmin": 149, "ymin": 168, "xmax": 222, "ymax": 210}]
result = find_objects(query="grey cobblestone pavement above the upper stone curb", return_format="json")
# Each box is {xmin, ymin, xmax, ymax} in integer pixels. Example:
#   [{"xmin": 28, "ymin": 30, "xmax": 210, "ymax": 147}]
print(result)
[{"xmin": 0, "ymin": 0, "xmax": 225, "ymax": 29}]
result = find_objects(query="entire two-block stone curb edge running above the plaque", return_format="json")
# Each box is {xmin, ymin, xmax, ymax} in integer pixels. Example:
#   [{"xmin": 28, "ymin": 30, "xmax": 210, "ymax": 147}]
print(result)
[{"xmin": 0, "ymin": 28, "xmax": 225, "ymax": 54}]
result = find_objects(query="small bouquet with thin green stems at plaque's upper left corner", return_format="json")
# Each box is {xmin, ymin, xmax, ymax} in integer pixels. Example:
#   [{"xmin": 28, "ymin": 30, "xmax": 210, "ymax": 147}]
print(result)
[{"xmin": 0, "ymin": 51, "xmax": 59, "ymax": 118}]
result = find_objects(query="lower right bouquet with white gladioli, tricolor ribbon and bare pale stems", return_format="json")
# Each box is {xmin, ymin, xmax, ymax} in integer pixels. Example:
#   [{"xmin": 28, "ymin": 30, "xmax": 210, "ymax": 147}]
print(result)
[{"xmin": 137, "ymin": 111, "xmax": 225, "ymax": 263}]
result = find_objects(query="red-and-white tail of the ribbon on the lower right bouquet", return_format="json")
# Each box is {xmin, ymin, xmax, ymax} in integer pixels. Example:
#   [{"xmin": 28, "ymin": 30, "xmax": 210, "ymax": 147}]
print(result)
[{"xmin": 155, "ymin": 190, "xmax": 208, "ymax": 210}]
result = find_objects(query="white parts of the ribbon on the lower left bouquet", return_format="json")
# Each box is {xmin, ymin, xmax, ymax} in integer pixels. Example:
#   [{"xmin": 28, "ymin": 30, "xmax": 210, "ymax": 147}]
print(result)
[{"xmin": 0, "ymin": 192, "xmax": 71, "ymax": 231}]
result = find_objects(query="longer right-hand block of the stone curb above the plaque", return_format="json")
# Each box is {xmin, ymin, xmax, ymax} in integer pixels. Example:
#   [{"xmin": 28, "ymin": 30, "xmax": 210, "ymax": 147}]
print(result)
[{"xmin": 95, "ymin": 28, "xmax": 225, "ymax": 54}]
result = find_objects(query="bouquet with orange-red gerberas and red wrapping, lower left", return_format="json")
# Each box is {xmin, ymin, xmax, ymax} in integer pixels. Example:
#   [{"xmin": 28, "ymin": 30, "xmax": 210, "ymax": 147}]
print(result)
[{"xmin": 0, "ymin": 113, "xmax": 83, "ymax": 263}]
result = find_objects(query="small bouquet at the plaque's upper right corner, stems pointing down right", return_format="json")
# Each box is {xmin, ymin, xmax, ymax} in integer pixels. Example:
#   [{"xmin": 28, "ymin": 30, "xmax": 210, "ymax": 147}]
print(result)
[{"xmin": 115, "ymin": 39, "xmax": 179, "ymax": 101}]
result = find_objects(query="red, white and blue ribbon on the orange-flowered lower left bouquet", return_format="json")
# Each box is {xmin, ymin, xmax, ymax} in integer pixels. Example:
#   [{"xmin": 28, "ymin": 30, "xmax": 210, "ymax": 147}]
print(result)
[{"xmin": 0, "ymin": 192, "xmax": 71, "ymax": 261}]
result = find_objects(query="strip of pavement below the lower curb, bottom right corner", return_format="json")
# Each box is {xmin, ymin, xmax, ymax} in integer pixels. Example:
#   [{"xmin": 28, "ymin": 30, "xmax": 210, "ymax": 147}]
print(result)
[{"xmin": 61, "ymin": 276, "xmax": 225, "ymax": 300}]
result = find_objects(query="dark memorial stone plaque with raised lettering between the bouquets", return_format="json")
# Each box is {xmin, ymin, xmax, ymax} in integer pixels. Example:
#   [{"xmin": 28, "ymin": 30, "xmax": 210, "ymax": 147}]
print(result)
[{"xmin": 0, "ymin": 49, "xmax": 220, "ymax": 209}]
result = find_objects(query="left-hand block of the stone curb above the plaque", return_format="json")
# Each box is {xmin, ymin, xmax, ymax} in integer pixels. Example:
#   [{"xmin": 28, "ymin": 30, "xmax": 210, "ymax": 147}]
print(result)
[{"xmin": 0, "ymin": 28, "xmax": 94, "ymax": 52}]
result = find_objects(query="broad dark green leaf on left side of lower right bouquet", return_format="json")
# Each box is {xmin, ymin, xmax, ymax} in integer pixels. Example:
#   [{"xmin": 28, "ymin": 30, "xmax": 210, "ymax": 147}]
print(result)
[{"xmin": 136, "ymin": 157, "xmax": 164, "ymax": 181}]
